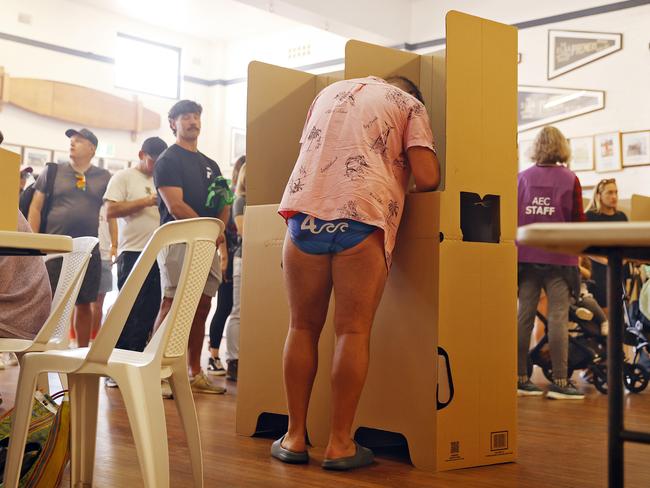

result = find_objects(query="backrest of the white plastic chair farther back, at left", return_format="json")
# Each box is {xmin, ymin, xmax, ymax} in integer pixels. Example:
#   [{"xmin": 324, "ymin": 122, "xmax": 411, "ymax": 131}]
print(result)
[{"xmin": 34, "ymin": 237, "xmax": 99, "ymax": 347}]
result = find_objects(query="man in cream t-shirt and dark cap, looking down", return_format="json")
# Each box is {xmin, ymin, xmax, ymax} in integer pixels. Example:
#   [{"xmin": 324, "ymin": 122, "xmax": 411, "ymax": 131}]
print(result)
[{"xmin": 104, "ymin": 137, "xmax": 167, "ymax": 370}]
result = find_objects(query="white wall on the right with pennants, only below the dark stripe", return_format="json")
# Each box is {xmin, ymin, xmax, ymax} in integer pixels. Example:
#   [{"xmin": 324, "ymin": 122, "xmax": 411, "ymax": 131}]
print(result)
[{"xmin": 519, "ymin": 5, "xmax": 650, "ymax": 198}]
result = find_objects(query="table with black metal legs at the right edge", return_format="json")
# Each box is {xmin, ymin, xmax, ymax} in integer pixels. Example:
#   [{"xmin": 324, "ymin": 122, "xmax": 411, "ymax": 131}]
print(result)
[{"xmin": 517, "ymin": 222, "xmax": 650, "ymax": 488}]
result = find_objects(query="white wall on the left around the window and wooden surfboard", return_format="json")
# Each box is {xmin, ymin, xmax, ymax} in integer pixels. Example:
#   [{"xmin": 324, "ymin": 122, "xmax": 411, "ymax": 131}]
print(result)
[{"xmin": 0, "ymin": 0, "xmax": 225, "ymax": 164}]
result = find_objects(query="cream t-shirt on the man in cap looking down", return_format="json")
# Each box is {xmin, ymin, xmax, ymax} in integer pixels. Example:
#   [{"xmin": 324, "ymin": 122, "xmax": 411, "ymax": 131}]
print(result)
[{"xmin": 104, "ymin": 168, "xmax": 160, "ymax": 254}]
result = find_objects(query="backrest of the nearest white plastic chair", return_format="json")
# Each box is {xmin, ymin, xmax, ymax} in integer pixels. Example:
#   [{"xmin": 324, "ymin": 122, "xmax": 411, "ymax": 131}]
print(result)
[{"xmin": 86, "ymin": 218, "xmax": 224, "ymax": 364}]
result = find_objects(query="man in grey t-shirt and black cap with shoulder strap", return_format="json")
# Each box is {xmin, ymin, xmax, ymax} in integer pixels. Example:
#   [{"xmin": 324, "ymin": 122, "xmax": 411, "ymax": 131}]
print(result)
[{"xmin": 29, "ymin": 129, "xmax": 111, "ymax": 347}]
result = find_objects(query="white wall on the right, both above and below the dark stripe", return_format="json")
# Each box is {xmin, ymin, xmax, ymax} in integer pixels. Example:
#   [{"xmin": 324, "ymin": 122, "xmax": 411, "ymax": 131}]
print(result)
[{"xmin": 411, "ymin": 0, "xmax": 650, "ymax": 198}]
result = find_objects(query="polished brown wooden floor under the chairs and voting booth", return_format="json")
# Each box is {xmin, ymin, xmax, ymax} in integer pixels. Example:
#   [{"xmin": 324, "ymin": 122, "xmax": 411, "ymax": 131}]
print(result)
[{"xmin": 0, "ymin": 367, "xmax": 650, "ymax": 488}]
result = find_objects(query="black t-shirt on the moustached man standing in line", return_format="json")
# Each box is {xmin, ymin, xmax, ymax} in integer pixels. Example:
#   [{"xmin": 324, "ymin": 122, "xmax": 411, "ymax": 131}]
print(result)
[{"xmin": 153, "ymin": 144, "xmax": 221, "ymax": 225}]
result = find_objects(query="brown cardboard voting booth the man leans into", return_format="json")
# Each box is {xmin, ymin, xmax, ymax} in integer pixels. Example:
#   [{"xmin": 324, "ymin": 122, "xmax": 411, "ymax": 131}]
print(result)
[{"xmin": 236, "ymin": 12, "xmax": 517, "ymax": 470}]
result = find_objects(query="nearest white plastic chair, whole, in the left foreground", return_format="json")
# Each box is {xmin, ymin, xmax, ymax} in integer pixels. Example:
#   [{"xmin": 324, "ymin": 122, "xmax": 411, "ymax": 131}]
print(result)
[{"xmin": 4, "ymin": 218, "xmax": 224, "ymax": 488}]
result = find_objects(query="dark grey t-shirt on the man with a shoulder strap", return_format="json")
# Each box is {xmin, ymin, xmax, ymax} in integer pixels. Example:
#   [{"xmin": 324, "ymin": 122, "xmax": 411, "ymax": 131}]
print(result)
[{"xmin": 36, "ymin": 163, "xmax": 111, "ymax": 237}]
